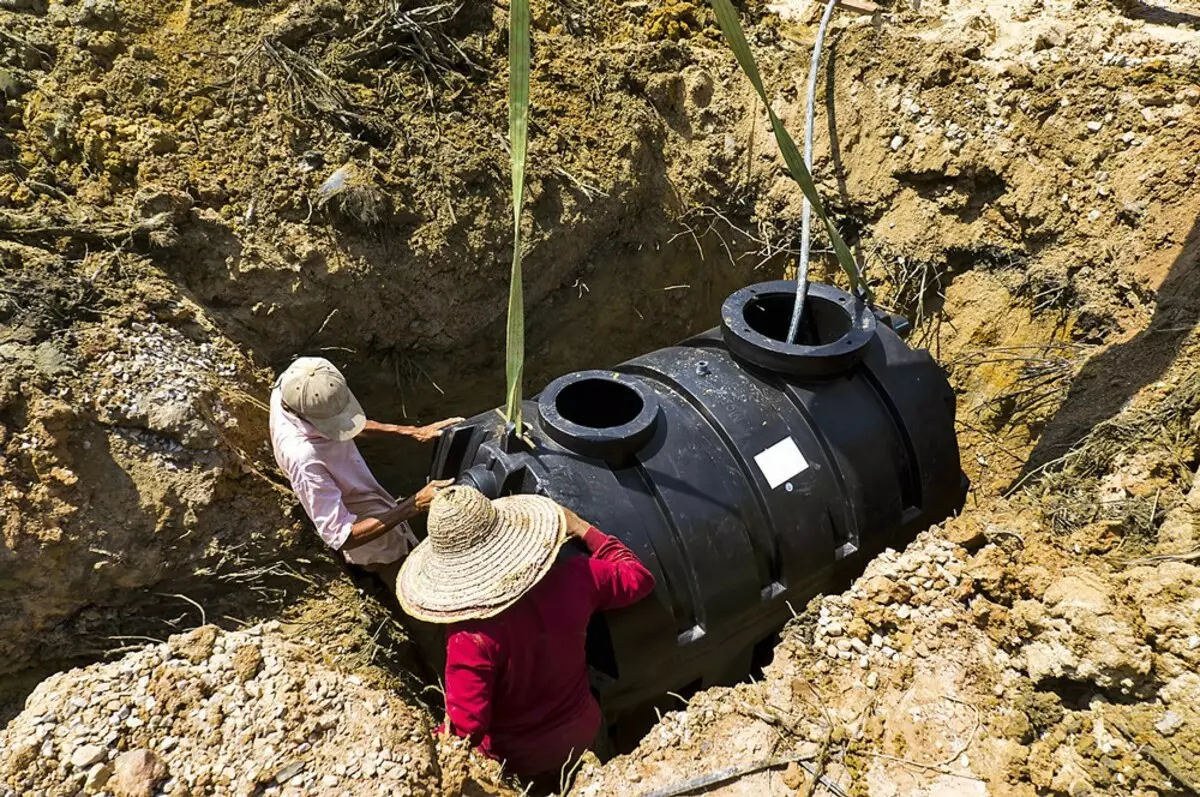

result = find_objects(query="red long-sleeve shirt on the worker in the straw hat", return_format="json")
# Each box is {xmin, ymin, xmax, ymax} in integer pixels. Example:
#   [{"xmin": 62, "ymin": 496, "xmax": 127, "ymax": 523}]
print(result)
[{"xmin": 445, "ymin": 528, "xmax": 654, "ymax": 775}]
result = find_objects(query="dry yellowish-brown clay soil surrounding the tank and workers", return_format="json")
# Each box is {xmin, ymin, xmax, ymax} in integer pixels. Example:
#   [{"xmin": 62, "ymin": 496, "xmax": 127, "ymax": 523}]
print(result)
[{"xmin": 0, "ymin": 0, "xmax": 1200, "ymax": 796}]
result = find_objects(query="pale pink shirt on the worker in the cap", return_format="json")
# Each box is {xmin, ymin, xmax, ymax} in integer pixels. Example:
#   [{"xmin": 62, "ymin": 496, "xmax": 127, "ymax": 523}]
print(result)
[{"xmin": 270, "ymin": 388, "xmax": 416, "ymax": 564}]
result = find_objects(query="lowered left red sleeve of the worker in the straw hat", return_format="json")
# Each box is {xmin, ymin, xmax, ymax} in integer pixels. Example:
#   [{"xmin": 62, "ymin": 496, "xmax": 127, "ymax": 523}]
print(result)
[{"xmin": 445, "ymin": 630, "xmax": 500, "ymax": 759}]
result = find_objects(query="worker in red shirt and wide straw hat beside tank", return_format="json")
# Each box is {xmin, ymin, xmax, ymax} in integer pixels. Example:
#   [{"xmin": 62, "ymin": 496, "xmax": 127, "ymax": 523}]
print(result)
[{"xmin": 396, "ymin": 486, "xmax": 654, "ymax": 785}]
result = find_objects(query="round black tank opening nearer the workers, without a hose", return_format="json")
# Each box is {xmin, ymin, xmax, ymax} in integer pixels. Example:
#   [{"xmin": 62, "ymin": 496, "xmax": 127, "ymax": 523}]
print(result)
[{"xmin": 538, "ymin": 371, "xmax": 659, "ymax": 461}]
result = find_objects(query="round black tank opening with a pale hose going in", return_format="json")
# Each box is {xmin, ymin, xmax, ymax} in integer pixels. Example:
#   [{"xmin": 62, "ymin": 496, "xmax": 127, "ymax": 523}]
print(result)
[{"xmin": 721, "ymin": 280, "xmax": 877, "ymax": 377}]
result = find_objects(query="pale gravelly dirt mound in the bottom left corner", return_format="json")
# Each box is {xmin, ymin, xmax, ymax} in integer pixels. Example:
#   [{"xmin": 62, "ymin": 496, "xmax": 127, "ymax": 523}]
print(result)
[{"xmin": 0, "ymin": 623, "xmax": 520, "ymax": 797}]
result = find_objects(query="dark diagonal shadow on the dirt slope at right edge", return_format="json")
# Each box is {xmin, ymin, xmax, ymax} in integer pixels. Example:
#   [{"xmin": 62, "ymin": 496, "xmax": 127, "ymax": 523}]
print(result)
[{"xmin": 1014, "ymin": 211, "xmax": 1200, "ymax": 486}]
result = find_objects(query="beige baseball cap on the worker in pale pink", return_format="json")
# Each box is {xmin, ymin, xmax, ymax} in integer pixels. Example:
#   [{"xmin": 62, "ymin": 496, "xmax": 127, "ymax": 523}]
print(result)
[{"xmin": 280, "ymin": 356, "xmax": 367, "ymax": 441}]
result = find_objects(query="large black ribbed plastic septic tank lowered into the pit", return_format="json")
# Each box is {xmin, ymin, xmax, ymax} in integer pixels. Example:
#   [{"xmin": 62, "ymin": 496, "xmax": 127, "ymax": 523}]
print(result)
[{"xmin": 432, "ymin": 282, "xmax": 966, "ymax": 719}]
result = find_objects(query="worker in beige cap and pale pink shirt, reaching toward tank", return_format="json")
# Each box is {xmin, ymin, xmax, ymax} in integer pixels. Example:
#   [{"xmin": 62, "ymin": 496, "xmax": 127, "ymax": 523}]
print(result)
[{"xmin": 270, "ymin": 356, "xmax": 462, "ymax": 585}]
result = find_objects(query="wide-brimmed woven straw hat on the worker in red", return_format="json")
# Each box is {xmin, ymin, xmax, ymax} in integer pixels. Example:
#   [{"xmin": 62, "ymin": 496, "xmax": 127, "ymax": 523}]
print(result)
[{"xmin": 396, "ymin": 486, "xmax": 566, "ymax": 623}]
